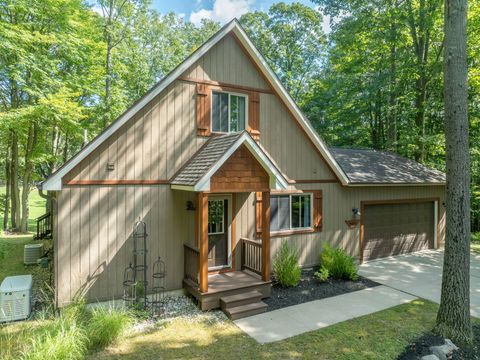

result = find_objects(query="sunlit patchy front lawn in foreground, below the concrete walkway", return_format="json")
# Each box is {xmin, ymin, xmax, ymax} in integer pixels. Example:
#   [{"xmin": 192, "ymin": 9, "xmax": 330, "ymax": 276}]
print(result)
[{"xmin": 90, "ymin": 300, "xmax": 446, "ymax": 360}]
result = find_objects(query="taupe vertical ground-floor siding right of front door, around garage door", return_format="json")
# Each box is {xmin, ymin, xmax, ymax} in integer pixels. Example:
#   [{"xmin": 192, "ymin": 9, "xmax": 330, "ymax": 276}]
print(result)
[{"xmin": 232, "ymin": 183, "xmax": 445, "ymax": 268}]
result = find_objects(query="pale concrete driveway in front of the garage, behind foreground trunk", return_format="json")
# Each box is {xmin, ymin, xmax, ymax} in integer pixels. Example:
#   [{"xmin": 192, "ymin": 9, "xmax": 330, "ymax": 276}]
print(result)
[{"xmin": 359, "ymin": 250, "xmax": 480, "ymax": 318}]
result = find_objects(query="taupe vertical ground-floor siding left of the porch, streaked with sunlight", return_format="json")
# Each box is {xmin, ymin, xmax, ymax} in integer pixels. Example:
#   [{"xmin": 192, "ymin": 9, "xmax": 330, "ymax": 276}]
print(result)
[{"xmin": 54, "ymin": 185, "xmax": 195, "ymax": 306}]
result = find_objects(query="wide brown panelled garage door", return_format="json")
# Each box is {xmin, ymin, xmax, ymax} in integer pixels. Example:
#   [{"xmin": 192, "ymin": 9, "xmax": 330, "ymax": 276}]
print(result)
[{"xmin": 363, "ymin": 202, "xmax": 435, "ymax": 261}]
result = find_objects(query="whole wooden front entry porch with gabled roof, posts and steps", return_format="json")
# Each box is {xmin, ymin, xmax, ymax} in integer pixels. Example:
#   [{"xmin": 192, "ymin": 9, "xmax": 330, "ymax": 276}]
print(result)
[{"xmin": 171, "ymin": 132, "xmax": 288, "ymax": 319}]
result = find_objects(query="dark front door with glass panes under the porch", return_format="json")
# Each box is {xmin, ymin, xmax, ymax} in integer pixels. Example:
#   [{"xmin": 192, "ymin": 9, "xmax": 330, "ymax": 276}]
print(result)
[{"xmin": 208, "ymin": 196, "xmax": 231, "ymax": 270}]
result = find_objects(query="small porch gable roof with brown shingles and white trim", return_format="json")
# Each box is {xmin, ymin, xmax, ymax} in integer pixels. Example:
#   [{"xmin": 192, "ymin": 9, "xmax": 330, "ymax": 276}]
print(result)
[{"xmin": 171, "ymin": 131, "xmax": 288, "ymax": 191}]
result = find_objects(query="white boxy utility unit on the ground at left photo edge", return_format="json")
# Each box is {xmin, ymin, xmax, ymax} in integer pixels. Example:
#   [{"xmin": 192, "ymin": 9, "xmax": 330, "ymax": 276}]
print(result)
[{"xmin": 0, "ymin": 275, "xmax": 32, "ymax": 323}]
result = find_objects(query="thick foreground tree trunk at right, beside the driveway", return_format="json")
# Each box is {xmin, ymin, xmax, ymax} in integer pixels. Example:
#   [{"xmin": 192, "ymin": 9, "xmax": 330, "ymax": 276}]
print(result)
[{"xmin": 435, "ymin": 0, "xmax": 472, "ymax": 343}]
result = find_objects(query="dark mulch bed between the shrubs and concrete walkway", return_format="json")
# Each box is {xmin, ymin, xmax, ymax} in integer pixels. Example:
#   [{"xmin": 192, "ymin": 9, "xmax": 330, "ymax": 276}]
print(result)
[{"xmin": 263, "ymin": 269, "xmax": 380, "ymax": 311}]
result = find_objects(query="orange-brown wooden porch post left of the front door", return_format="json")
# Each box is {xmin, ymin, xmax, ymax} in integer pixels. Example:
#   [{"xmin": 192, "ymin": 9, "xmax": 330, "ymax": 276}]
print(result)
[{"xmin": 197, "ymin": 192, "xmax": 208, "ymax": 292}]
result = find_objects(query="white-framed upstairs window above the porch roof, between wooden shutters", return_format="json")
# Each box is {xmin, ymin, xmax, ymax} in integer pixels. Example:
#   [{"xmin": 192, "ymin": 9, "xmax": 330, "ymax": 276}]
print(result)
[{"xmin": 212, "ymin": 91, "xmax": 247, "ymax": 132}]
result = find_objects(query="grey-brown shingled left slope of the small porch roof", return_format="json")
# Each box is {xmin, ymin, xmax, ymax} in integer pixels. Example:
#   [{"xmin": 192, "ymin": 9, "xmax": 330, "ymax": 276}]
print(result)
[{"xmin": 172, "ymin": 132, "xmax": 243, "ymax": 185}]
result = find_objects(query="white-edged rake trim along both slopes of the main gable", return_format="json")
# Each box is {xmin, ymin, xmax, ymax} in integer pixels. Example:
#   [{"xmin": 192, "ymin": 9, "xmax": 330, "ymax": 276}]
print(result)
[{"xmin": 41, "ymin": 19, "xmax": 348, "ymax": 191}]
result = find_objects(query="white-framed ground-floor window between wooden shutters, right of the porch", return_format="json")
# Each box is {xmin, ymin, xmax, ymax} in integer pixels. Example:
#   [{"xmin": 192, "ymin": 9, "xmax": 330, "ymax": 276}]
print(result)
[{"xmin": 270, "ymin": 194, "xmax": 312, "ymax": 231}]
